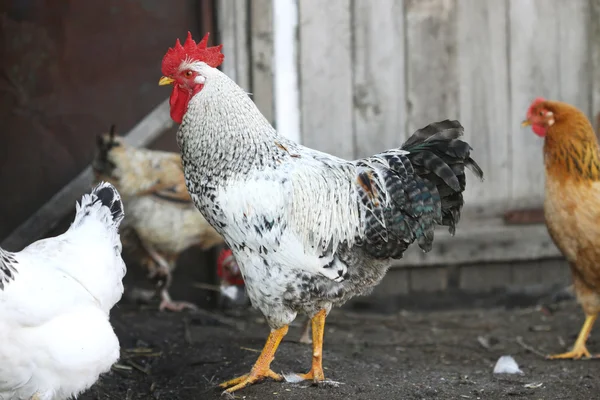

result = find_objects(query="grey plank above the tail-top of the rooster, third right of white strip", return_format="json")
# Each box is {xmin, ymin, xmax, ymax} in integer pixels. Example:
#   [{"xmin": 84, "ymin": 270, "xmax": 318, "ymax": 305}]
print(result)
[{"xmin": 405, "ymin": 0, "xmax": 458, "ymax": 132}]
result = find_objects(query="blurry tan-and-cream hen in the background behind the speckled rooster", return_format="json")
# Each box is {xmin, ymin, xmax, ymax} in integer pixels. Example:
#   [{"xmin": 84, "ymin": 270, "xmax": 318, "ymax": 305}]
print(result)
[{"xmin": 92, "ymin": 126, "xmax": 223, "ymax": 311}]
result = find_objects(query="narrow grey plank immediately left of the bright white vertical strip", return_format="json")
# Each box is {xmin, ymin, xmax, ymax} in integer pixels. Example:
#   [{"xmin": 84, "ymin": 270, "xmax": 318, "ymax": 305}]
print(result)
[{"xmin": 250, "ymin": 0, "xmax": 275, "ymax": 124}]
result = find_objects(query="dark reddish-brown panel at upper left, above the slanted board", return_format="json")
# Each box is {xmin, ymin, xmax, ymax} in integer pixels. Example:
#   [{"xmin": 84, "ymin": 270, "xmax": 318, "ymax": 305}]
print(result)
[{"xmin": 0, "ymin": 0, "xmax": 202, "ymax": 237}]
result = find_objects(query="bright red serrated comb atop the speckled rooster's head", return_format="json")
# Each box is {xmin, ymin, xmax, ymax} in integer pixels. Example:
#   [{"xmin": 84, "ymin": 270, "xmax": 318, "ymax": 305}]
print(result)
[{"xmin": 162, "ymin": 32, "xmax": 225, "ymax": 76}]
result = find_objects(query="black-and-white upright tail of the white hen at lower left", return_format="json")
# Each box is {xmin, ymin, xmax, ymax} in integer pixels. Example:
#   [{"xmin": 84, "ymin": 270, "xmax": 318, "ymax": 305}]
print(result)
[{"xmin": 70, "ymin": 182, "xmax": 125, "ymax": 233}]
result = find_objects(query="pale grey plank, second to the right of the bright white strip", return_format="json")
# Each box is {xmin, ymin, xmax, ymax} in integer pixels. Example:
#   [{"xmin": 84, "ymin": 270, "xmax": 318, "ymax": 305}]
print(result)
[{"xmin": 352, "ymin": 0, "xmax": 407, "ymax": 157}]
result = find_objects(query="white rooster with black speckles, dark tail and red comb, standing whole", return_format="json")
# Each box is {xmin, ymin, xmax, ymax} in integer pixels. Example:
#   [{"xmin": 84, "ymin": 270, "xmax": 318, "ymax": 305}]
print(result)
[{"xmin": 159, "ymin": 33, "xmax": 483, "ymax": 394}]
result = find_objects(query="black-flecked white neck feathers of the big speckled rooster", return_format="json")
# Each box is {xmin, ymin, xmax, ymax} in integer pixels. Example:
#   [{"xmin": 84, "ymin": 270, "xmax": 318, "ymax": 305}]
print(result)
[{"xmin": 177, "ymin": 72, "xmax": 280, "ymax": 179}]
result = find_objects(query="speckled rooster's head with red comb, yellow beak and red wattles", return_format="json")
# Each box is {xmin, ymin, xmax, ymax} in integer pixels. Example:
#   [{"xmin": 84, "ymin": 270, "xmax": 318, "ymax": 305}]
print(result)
[{"xmin": 158, "ymin": 32, "xmax": 225, "ymax": 124}]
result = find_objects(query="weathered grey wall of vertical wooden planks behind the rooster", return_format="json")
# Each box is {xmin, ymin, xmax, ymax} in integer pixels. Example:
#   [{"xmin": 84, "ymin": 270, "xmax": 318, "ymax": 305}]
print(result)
[{"xmin": 219, "ymin": 0, "xmax": 600, "ymax": 215}]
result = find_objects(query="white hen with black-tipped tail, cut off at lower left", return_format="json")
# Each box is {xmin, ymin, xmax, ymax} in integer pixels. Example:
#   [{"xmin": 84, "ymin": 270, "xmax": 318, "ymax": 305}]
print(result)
[{"xmin": 0, "ymin": 183, "xmax": 126, "ymax": 400}]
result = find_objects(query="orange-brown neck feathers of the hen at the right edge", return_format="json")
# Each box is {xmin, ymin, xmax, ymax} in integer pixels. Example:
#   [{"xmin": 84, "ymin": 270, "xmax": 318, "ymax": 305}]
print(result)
[{"xmin": 544, "ymin": 114, "xmax": 600, "ymax": 183}]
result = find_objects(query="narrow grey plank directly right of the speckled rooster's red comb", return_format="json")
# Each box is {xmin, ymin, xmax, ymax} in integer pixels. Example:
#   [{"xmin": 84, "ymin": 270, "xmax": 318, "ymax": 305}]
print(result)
[{"xmin": 217, "ymin": 0, "xmax": 251, "ymax": 91}]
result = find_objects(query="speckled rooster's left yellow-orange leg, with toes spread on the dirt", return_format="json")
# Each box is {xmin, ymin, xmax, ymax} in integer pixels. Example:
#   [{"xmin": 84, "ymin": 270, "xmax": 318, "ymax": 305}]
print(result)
[{"xmin": 219, "ymin": 325, "xmax": 288, "ymax": 393}]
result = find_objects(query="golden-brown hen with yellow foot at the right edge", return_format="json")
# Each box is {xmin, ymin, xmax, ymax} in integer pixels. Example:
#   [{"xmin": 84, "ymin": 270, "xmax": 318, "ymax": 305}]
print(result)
[{"xmin": 523, "ymin": 98, "xmax": 600, "ymax": 359}]
